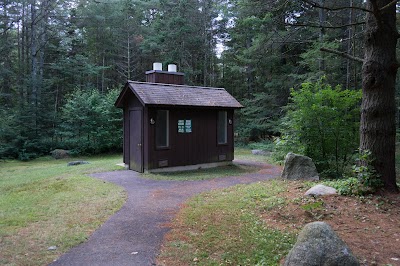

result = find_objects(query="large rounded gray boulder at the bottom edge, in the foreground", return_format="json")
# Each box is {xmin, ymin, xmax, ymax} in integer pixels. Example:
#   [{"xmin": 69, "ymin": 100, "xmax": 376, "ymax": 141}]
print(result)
[{"xmin": 284, "ymin": 222, "xmax": 360, "ymax": 266}]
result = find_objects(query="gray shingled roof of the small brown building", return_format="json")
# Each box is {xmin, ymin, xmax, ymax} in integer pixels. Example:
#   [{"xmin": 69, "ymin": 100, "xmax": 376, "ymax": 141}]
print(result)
[{"xmin": 128, "ymin": 81, "xmax": 243, "ymax": 108}]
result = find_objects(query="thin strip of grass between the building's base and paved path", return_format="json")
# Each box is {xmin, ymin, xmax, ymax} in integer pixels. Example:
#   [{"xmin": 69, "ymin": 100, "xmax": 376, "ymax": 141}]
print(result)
[{"xmin": 142, "ymin": 164, "xmax": 259, "ymax": 181}]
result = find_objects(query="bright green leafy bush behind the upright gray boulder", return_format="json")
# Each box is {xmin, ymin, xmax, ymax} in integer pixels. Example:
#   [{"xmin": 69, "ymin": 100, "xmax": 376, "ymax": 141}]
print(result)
[{"xmin": 274, "ymin": 78, "xmax": 361, "ymax": 177}]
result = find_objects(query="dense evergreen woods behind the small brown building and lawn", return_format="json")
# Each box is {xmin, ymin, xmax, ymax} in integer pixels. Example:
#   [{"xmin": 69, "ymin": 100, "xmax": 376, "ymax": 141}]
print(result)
[{"xmin": 0, "ymin": 0, "xmax": 399, "ymax": 191}]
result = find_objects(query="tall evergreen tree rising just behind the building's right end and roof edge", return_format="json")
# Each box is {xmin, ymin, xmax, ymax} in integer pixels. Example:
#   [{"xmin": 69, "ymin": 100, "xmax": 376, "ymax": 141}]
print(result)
[{"xmin": 222, "ymin": 1, "xmax": 302, "ymax": 143}]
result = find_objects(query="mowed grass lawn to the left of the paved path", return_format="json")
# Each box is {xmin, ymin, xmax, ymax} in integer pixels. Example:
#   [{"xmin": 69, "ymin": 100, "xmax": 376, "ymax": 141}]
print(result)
[{"xmin": 0, "ymin": 155, "xmax": 126, "ymax": 265}]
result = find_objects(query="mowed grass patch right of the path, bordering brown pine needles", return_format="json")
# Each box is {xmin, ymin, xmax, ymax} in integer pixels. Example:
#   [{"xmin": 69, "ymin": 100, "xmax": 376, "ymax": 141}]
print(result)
[{"xmin": 158, "ymin": 180, "xmax": 295, "ymax": 265}]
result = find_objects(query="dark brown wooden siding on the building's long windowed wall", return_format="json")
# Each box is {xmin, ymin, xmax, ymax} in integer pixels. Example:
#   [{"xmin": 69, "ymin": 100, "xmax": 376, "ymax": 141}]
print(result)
[{"xmin": 144, "ymin": 108, "xmax": 234, "ymax": 170}]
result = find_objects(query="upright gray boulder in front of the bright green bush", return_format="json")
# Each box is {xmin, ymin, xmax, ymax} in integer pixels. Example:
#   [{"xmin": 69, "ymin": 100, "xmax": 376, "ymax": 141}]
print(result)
[{"xmin": 282, "ymin": 152, "xmax": 319, "ymax": 180}]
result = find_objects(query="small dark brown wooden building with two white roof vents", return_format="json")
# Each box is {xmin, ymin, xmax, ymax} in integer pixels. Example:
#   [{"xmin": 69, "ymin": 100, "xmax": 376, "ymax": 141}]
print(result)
[{"xmin": 115, "ymin": 65, "xmax": 242, "ymax": 172}]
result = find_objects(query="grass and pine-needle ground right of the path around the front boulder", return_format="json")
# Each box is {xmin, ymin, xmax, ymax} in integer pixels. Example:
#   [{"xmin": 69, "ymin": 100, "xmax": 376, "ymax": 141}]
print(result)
[{"xmin": 158, "ymin": 180, "xmax": 400, "ymax": 265}]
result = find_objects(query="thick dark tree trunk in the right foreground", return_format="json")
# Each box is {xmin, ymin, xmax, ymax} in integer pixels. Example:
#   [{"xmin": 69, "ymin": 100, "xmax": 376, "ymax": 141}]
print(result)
[{"xmin": 360, "ymin": 0, "xmax": 398, "ymax": 191}]
